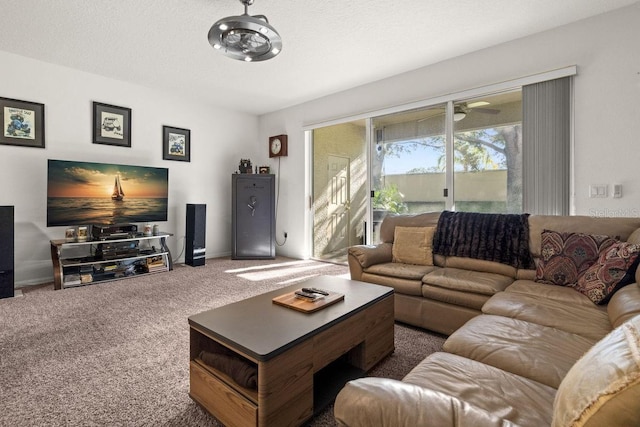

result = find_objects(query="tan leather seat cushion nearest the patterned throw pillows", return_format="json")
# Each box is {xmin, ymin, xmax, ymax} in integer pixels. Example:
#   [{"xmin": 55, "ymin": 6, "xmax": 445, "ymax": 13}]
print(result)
[{"xmin": 482, "ymin": 291, "xmax": 611, "ymax": 342}]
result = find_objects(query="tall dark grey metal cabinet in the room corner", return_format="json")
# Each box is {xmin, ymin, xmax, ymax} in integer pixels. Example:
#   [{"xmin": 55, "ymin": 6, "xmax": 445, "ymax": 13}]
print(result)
[{"xmin": 231, "ymin": 174, "xmax": 276, "ymax": 259}]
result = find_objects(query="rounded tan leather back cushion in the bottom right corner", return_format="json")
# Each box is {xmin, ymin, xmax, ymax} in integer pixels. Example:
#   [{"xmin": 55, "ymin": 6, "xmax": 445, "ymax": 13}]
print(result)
[{"xmin": 552, "ymin": 316, "xmax": 640, "ymax": 427}]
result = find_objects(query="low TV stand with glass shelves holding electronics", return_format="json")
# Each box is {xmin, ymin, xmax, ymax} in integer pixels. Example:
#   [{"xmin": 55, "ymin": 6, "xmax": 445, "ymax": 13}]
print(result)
[{"xmin": 51, "ymin": 233, "xmax": 173, "ymax": 289}]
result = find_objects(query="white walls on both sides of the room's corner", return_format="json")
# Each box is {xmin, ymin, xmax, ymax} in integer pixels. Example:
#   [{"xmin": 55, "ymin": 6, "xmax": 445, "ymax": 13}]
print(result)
[{"xmin": 5, "ymin": 3, "xmax": 640, "ymax": 285}]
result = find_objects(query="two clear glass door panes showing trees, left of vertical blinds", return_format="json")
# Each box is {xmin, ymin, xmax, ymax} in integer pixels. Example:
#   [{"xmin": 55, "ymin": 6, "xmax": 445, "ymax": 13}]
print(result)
[{"xmin": 371, "ymin": 90, "xmax": 522, "ymax": 243}]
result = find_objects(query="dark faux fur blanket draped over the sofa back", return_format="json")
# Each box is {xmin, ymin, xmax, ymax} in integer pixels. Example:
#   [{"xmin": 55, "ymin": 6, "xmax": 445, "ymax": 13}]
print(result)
[{"xmin": 433, "ymin": 211, "xmax": 535, "ymax": 269}]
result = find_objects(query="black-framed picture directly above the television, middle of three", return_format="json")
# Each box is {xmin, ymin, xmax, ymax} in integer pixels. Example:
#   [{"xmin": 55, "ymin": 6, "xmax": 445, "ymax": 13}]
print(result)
[{"xmin": 93, "ymin": 102, "xmax": 131, "ymax": 147}]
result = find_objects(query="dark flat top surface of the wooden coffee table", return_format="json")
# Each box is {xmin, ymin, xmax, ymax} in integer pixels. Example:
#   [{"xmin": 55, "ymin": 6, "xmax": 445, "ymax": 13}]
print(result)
[{"xmin": 189, "ymin": 276, "xmax": 393, "ymax": 361}]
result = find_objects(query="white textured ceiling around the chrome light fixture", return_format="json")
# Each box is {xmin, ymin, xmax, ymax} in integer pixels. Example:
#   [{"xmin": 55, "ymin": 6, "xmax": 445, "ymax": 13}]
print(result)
[{"xmin": 0, "ymin": 0, "xmax": 637, "ymax": 114}]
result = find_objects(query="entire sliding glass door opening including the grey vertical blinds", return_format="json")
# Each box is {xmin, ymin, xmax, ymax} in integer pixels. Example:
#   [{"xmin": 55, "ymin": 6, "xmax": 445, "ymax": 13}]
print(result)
[{"xmin": 311, "ymin": 75, "xmax": 572, "ymax": 252}]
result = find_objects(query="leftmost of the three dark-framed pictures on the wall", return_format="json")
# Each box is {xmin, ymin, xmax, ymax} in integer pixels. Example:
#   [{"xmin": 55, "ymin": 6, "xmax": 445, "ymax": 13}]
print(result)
[{"xmin": 0, "ymin": 98, "xmax": 44, "ymax": 148}]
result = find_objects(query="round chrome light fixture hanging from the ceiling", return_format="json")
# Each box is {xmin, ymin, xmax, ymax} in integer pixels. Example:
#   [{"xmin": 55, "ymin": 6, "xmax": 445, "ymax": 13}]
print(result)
[{"xmin": 209, "ymin": 0, "xmax": 282, "ymax": 62}]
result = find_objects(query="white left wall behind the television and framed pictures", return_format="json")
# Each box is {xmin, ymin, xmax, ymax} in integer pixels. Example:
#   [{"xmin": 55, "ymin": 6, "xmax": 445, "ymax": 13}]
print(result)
[{"xmin": 0, "ymin": 52, "xmax": 266, "ymax": 286}]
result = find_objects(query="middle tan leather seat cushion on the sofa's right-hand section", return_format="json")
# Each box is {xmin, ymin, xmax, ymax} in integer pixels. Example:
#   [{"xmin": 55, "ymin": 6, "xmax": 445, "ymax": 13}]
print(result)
[{"xmin": 443, "ymin": 314, "xmax": 593, "ymax": 388}]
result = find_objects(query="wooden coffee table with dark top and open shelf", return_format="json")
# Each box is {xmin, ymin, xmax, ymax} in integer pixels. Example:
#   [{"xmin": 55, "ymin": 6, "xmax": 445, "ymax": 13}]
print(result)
[{"xmin": 189, "ymin": 276, "xmax": 394, "ymax": 426}]
